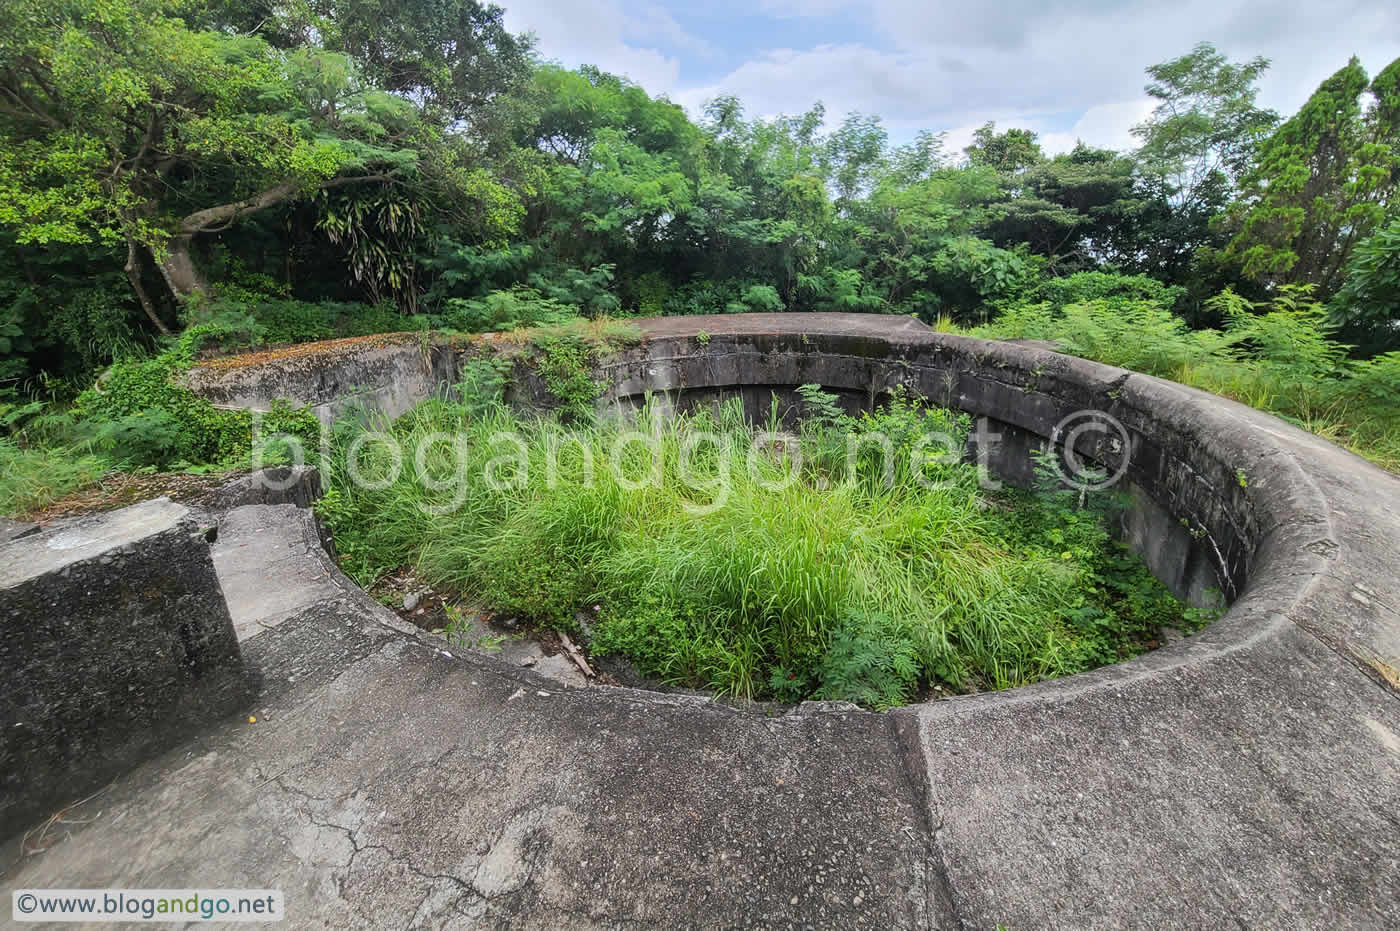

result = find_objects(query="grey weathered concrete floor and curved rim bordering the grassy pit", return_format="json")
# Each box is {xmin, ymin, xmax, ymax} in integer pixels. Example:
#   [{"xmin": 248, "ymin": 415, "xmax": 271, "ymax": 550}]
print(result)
[{"xmin": 35, "ymin": 315, "xmax": 1400, "ymax": 928}]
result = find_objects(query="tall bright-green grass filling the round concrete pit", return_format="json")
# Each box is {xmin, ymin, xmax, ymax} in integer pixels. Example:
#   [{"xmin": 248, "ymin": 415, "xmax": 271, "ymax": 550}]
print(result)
[{"xmin": 321, "ymin": 383, "xmax": 1198, "ymax": 707}]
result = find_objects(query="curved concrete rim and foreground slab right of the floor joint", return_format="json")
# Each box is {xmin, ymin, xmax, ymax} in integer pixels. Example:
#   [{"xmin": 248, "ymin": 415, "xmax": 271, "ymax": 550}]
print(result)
[{"xmin": 605, "ymin": 315, "xmax": 1400, "ymax": 927}]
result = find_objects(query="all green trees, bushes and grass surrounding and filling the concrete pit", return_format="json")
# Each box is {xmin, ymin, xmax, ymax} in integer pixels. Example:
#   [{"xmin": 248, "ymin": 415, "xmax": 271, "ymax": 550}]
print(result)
[{"xmin": 0, "ymin": 0, "xmax": 1400, "ymax": 707}]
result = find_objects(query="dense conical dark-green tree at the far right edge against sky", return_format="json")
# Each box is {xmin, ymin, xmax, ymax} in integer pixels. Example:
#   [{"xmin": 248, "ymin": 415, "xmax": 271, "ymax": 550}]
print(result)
[{"xmin": 1226, "ymin": 57, "xmax": 1400, "ymax": 294}]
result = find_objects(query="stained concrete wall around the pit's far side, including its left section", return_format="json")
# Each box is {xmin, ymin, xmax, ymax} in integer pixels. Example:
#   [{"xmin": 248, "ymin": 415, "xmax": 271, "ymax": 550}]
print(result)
[{"xmin": 180, "ymin": 314, "xmax": 1338, "ymax": 616}]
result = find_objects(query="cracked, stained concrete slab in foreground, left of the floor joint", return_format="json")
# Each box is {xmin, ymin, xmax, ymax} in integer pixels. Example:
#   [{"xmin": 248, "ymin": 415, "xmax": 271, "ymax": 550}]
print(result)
[{"xmin": 6, "ymin": 505, "xmax": 946, "ymax": 928}]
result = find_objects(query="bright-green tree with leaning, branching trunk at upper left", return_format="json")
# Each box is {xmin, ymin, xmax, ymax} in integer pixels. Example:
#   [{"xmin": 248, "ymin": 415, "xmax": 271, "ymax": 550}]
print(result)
[{"xmin": 0, "ymin": 0, "xmax": 526, "ymax": 319}]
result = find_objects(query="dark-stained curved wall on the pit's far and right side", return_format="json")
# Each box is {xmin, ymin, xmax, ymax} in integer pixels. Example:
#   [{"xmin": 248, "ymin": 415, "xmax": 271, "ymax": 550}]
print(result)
[{"xmin": 603, "ymin": 314, "xmax": 1259, "ymax": 605}]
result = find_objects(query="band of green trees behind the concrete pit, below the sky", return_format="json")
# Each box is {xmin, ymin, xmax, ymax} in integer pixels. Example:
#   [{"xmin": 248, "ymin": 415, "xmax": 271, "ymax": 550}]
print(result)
[{"xmin": 0, "ymin": 0, "xmax": 1400, "ymax": 378}]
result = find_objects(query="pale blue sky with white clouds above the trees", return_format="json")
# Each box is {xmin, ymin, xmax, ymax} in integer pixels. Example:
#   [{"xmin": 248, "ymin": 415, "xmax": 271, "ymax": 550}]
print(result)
[{"xmin": 496, "ymin": 0, "xmax": 1400, "ymax": 153}]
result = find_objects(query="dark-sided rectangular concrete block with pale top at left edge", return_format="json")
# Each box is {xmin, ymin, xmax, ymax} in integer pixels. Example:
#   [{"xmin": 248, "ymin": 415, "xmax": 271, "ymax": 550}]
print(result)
[{"xmin": 0, "ymin": 498, "xmax": 249, "ymax": 837}]
